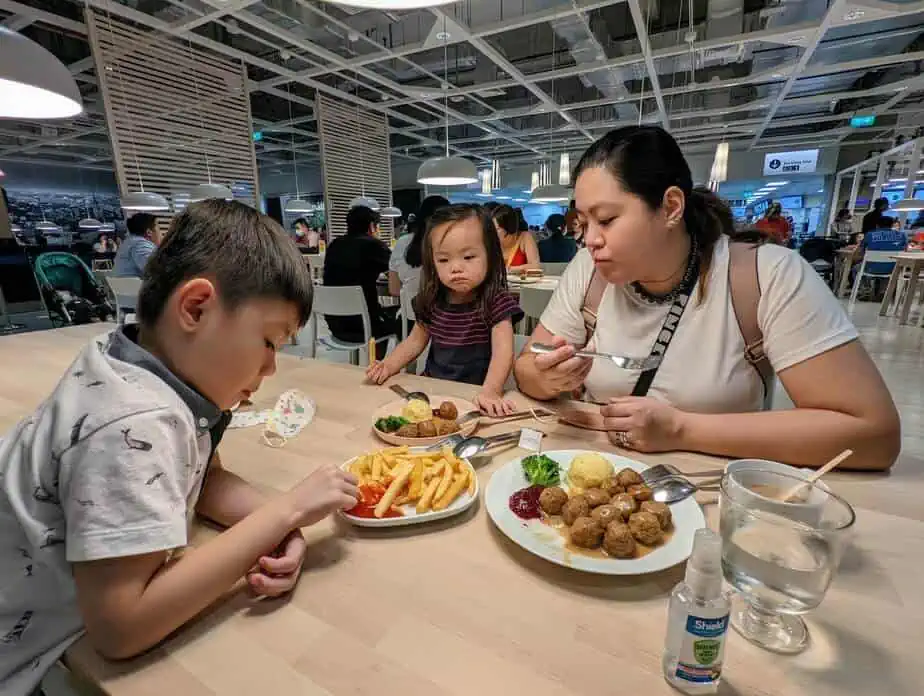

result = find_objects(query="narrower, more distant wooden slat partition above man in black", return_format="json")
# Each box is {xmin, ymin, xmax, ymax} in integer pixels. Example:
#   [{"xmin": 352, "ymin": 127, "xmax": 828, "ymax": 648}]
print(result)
[{"xmin": 316, "ymin": 94, "xmax": 394, "ymax": 242}]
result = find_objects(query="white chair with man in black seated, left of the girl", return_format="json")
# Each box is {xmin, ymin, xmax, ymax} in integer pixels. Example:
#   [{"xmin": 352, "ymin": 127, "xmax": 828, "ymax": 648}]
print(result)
[{"xmin": 285, "ymin": 285, "xmax": 397, "ymax": 365}]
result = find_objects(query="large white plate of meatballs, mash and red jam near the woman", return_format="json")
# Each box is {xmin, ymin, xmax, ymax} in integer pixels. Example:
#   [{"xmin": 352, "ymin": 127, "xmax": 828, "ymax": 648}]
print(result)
[{"xmin": 485, "ymin": 450, "xmax": 706, "ymax": 575}]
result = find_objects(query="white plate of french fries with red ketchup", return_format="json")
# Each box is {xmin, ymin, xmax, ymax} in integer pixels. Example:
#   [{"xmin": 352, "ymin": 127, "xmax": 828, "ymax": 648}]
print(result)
[{"xmin": 340, "ymin": 446, "xmax": 478, "ymax": 527}]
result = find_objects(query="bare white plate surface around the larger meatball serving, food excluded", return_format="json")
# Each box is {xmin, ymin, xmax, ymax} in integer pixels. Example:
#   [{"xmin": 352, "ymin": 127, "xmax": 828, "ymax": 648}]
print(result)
[{"xmin": 484, "ymin": 450, "xmax": 706, "ymax": 575}]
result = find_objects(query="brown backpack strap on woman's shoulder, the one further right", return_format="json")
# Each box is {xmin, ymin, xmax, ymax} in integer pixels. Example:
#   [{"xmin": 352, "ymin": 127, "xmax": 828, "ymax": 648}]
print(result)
[{"xmin": 728, "ymin": 242, "xmax": 773, "ymax": 402}]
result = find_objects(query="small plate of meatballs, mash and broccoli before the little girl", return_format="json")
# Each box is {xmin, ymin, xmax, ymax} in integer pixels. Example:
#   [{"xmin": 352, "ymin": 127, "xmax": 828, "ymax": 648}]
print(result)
[{"xmin": 372, "ymin": 394, "xmax": 478, "ymax": 447}]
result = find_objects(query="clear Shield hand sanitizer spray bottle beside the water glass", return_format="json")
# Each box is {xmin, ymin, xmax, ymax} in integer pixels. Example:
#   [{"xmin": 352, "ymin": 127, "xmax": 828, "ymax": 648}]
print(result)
[{"xmin": 662, "ymin": 529, "xmax": 731, "ymax": 694}]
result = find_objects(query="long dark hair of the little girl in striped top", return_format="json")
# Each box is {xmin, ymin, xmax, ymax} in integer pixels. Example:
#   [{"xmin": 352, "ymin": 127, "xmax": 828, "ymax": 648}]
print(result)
[{"xmin": 414, "ymin": 203, "xmax": 507, "ymax": 324}]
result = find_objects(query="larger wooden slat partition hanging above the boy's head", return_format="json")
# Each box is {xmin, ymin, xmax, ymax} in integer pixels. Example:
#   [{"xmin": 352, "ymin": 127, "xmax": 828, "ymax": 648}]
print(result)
[{"xmin": 87, "ymin": 8, "xmax": 260, "ymax": 215}]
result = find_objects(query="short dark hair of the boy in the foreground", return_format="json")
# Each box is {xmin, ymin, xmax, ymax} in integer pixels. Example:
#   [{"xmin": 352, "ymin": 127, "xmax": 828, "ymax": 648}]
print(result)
[{"xmin": 137, "ymin": 199, "xmax": 312, "ymax": 327}]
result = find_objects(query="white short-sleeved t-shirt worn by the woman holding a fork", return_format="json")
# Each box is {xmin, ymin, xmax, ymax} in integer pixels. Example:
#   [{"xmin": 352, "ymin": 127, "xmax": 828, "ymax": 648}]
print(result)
[{"xmin": 541, "ymin": 237, "xmax": 857, "ymax": 413}]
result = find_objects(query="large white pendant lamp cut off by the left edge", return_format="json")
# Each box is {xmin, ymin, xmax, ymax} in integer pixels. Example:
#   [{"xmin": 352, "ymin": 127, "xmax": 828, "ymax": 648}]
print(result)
[{"xmin": 0, "ymin": 26, "xmax": 83, "ymax": 119}]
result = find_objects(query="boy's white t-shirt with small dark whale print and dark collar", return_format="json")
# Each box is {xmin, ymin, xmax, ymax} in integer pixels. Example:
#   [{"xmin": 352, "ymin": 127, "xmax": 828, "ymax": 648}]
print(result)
[{"xmin": 0, "ymin": 327, "xmax": 229, "ymax": 696}]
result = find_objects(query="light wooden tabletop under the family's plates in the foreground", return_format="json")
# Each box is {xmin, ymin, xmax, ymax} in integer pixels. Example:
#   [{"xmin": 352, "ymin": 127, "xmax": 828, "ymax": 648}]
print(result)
[{"xmin": 0, "ymin": 325, "xmax": 924, "ymax": 696}]
